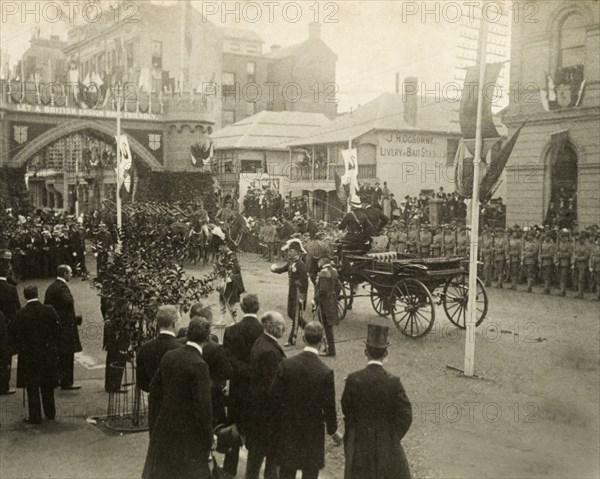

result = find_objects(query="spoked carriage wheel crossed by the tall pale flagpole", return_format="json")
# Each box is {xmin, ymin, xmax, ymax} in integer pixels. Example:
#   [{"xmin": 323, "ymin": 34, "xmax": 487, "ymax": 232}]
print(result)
[{"xmin": 442, "ymin": 273, "xmax": 488, "ymax": 329}]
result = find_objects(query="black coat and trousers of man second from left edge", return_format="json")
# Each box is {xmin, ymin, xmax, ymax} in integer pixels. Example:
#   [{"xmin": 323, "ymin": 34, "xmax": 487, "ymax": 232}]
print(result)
[{"xmin": 14, "ymin": 301, "xmax": 60, "ymax": 422}]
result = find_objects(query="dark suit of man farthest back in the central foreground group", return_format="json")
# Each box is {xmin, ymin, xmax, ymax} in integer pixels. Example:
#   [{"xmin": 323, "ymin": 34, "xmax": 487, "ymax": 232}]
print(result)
[{"xmin": 223, "ymin": 316, "xmax": 263, "ymax": 476}]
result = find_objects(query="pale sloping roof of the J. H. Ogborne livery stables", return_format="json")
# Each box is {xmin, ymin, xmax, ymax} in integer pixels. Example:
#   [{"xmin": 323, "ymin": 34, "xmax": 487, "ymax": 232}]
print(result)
[{"xmin": 289, "ymin": 93, "xmax": 460, "ymax": 146}]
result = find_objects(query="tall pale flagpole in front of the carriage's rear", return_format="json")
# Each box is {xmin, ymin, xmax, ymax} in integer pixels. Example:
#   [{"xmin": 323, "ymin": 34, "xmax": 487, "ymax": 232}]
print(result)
[{"xmin": 465, "ymin": 2, "xmax": 488, "ymax": 377}]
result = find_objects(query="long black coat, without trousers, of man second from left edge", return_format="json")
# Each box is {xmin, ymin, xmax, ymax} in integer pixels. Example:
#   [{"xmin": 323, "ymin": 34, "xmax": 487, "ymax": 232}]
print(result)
[{"xmin": 14, "ymin": 301, "xmax": 60, "ymax": 388}]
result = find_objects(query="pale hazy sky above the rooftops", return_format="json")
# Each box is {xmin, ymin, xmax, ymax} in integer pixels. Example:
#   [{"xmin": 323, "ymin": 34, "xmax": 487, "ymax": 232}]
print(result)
[{"xmin": 0, "ymin": 0, "xmax": 510, "ymax": 111}]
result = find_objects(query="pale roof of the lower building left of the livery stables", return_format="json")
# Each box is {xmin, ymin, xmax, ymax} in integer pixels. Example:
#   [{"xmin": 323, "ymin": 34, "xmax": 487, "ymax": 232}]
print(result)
[{"xmin": 212, "ymin": 111, "xmax": 329, "ymax": 150}]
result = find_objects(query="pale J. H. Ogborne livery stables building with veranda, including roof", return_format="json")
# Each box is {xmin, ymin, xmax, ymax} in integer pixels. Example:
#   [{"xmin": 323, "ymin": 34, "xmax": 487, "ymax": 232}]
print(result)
[{"xmin": 289, "ymin": 87, "xmax": 461, "ymax": 218}]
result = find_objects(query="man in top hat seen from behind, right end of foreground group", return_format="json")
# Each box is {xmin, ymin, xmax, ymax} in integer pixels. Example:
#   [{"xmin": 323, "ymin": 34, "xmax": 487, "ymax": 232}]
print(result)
[{"xmin": 342, "ymin": 324, "xmax": 412, "ymax": 479}]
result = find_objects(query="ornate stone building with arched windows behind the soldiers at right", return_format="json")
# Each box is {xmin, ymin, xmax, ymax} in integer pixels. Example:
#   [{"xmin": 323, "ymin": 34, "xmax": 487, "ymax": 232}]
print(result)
[{"xmin": 503, "ymin": 1, "xmax": 600, "ymax": 229}]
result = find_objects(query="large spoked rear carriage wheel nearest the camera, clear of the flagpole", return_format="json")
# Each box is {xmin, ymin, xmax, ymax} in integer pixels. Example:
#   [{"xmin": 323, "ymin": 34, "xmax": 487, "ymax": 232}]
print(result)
[{"xmin": 389, "ymin": 278, "xmax": 435, "ymax": 338}]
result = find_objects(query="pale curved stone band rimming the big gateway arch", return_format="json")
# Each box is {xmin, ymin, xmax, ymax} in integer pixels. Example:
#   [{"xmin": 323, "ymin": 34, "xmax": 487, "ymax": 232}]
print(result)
[{"xmin": 13, "ymin": 120, "xmax": 163, "ymax": 171}]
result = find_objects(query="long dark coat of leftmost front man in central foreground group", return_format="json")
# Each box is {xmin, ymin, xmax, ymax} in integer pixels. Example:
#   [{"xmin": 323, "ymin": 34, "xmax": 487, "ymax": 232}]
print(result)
[{"xmin": 142, "ymin": 346, "xmax": 213, "ymax": 479}]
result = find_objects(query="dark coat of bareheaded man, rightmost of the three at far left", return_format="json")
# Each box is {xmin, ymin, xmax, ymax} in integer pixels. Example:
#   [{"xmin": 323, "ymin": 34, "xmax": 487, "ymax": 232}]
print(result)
[{"xmin": 44, "ymin": 279, "xmax": 82, "ymax": 354}]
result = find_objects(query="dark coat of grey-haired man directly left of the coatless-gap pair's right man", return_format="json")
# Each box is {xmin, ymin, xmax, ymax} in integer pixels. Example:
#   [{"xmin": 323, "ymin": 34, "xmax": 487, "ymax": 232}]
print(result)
[{"xmin": 246, "ymin": 334, "xmax": 285, "ymax": 456}]
